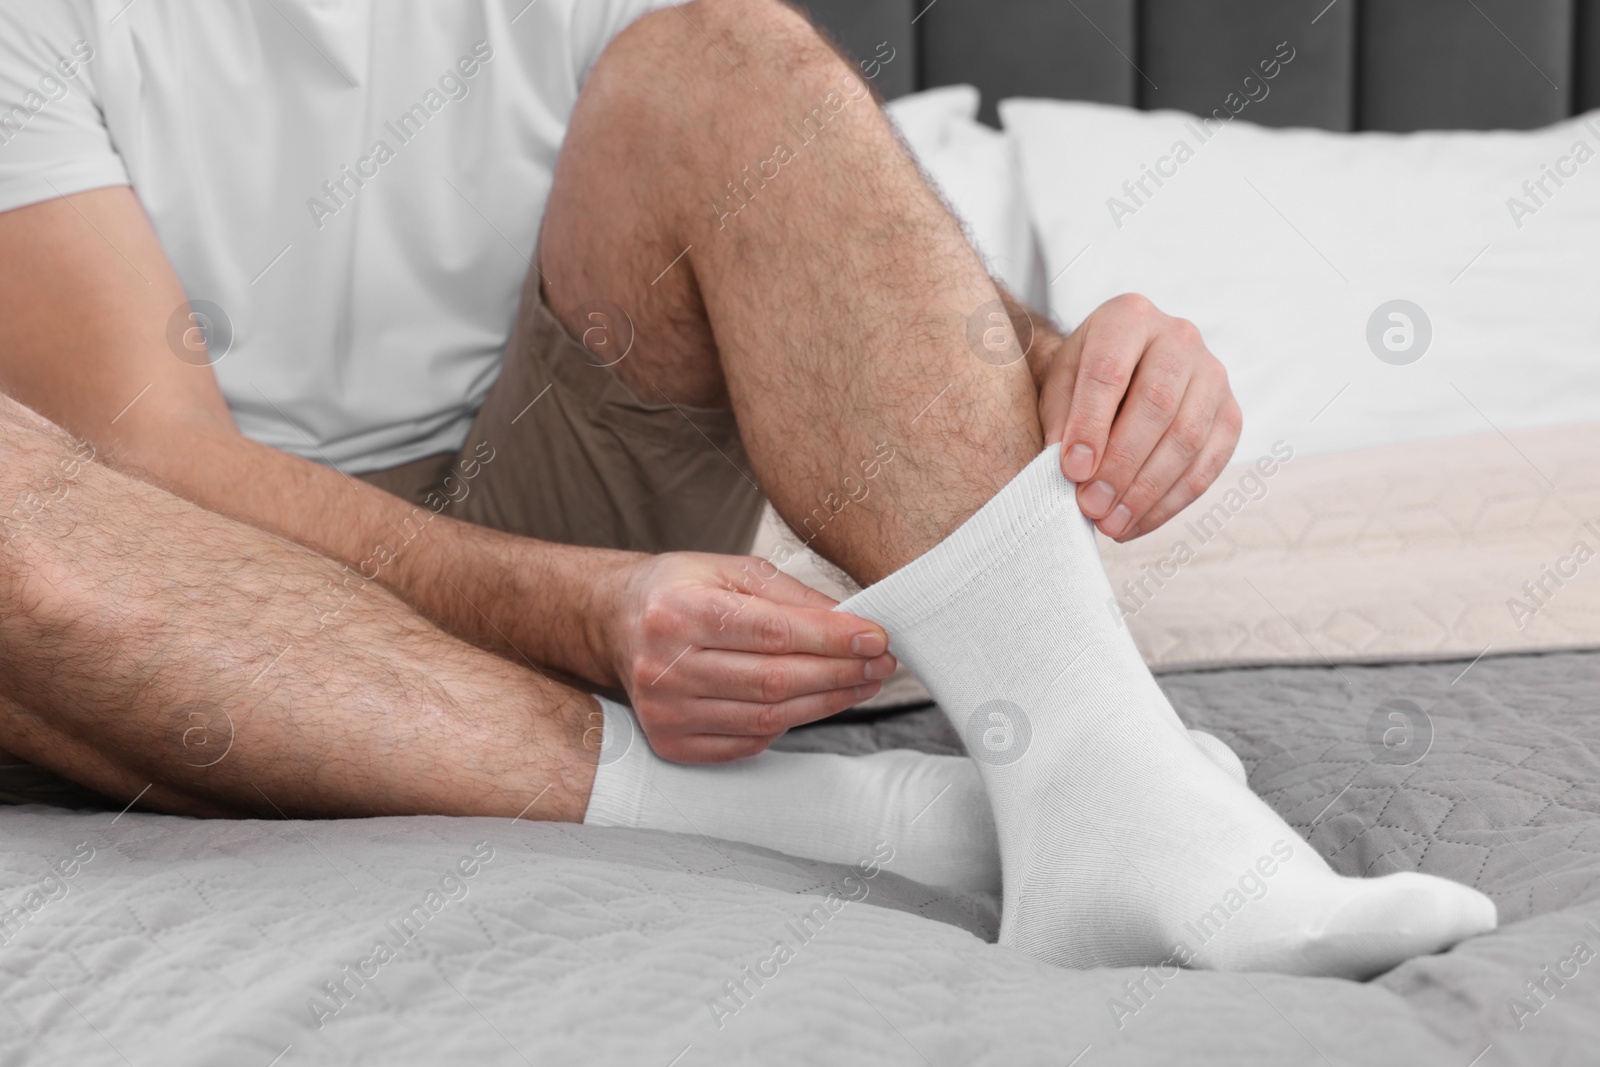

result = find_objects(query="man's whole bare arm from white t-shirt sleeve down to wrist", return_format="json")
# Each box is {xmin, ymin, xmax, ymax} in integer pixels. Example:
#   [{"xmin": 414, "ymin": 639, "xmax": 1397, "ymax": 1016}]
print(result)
[{"xmin": 0, "ymin": 187, "xmax": 621, "ymax": 681}]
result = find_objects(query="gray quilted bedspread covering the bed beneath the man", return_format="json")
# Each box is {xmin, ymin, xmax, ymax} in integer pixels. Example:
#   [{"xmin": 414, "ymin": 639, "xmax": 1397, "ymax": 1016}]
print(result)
[{"xmin": 0, "ymin": 653, "xmax": 1600, "ymax": 1067}]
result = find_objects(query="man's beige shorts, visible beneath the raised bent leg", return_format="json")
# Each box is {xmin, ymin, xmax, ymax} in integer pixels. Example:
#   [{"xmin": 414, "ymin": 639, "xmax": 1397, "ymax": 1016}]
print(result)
[{"xmin": 362, "ymin": 275, "xmax": 763, "ymax": 553}]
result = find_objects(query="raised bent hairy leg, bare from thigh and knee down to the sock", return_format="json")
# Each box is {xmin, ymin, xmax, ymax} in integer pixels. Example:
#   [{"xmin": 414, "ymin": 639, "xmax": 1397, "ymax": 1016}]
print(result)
[{"xmin": 539, "ymin": 0, "xmax": 1043, "ymax": 582}]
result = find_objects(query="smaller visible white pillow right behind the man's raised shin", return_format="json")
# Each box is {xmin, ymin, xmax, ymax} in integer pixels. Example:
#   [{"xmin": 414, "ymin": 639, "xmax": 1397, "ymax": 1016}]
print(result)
[{"xmin": 885, "ymin": 85, "xmax": 1043, "ymax": 307}]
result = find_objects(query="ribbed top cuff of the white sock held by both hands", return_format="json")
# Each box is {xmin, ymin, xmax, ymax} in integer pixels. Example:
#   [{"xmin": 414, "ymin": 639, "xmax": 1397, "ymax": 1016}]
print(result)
[{"xmin": 835, "ymin": 445, "xmax": 1093, "ymax": 632}]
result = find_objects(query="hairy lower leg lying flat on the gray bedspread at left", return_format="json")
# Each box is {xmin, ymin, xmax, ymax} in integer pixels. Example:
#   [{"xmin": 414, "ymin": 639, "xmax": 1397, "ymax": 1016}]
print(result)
[{"xmin": 0, "ymin": 397, "xmax": 602, "ymax": 821}]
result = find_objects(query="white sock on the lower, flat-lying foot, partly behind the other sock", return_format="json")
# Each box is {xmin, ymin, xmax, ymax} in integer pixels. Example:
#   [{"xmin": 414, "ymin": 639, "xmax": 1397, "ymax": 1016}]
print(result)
[{"xmin": 584, "ymin": 697, "xmax": 1000, "ymax": 894}]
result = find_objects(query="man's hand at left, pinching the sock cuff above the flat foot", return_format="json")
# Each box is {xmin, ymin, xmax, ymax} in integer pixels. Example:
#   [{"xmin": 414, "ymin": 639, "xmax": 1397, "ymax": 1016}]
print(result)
[{"xmin": 603, "ymin": 552, "xmax": 894, "ymax": 763}]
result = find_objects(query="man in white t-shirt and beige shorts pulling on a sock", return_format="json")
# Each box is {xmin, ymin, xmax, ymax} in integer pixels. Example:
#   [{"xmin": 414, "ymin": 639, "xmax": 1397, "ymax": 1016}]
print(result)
[{"xmin": 0, "ymin": 0, "xmax": 1494, "ymax": 974}]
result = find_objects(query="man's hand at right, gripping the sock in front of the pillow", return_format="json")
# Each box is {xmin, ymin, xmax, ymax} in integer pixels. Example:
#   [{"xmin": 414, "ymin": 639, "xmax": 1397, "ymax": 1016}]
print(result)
[{"xmin": 1038, "ymin": 294, "xmax": 1242, "ymax": 541}]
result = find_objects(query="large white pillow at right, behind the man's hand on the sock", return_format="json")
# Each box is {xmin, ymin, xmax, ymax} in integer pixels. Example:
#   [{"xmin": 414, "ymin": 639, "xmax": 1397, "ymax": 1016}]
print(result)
[{"xmin": 1000, "ymin": 99, "xmax": 1600, "ymax": 461}]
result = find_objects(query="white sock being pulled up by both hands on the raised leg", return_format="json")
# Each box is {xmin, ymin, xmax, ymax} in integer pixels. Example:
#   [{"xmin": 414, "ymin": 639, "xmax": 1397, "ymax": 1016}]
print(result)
[{"xmin": 838, "ymin": 446, "xmax": 1494, "ymax": 977}]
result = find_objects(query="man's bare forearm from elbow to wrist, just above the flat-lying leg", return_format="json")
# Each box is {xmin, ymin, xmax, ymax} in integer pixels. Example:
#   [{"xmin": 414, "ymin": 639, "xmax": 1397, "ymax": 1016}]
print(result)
[{"xmin": 114, "ymin": 421, "xmax": 637, "ymax": 685}]
